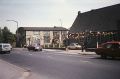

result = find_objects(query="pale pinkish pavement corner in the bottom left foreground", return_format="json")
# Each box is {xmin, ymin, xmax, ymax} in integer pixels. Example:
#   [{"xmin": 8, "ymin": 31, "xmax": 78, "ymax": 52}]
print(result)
[{"xmin": 0, "ymin": 59, "xmax": 41, "ymax": 79}]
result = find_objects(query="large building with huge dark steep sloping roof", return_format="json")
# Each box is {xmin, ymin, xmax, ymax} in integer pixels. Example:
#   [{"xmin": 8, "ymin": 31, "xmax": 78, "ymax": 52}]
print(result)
[{"xmin": 69, "ymin": 4, "xmax": 120, "ymax": 47}]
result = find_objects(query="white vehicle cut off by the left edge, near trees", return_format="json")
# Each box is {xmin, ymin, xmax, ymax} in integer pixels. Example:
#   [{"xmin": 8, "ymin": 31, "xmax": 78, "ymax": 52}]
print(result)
[{"xmin": 0, "ymin": 43, "xmax": 12, "ymax": 53}]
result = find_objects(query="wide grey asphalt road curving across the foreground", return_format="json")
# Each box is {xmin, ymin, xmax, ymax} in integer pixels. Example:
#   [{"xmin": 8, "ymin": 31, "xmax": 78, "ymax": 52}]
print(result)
[{"xmin": 0, "ymin": 50, "xmax": 120, "ymax": 79}]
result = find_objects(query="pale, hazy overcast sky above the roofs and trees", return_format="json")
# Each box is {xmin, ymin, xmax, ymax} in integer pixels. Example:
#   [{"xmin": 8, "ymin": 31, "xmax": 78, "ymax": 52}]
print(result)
[{"xmin": 0, "ymin": 0, "xmax": 120, "ymax": 33}]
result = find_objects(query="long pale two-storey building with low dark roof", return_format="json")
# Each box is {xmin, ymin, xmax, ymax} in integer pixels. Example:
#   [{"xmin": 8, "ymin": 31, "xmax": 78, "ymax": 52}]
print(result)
[{"xmin": 19, "ymin": 26, "xmax": 68, "ymax": 47}]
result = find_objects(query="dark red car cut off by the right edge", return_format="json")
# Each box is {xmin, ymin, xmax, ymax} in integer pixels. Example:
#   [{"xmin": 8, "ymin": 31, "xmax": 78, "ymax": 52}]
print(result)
[{"xmin": 95, "ymin": 41, "xmax": 120, "ymax": 58}]
